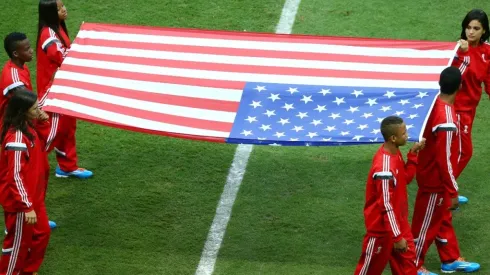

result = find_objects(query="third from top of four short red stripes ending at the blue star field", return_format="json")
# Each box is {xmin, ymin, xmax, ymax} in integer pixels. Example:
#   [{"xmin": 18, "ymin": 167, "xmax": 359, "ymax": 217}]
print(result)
[{"xmin": 51, "ymin": 93, "xmax": 233, "ymax": 132}]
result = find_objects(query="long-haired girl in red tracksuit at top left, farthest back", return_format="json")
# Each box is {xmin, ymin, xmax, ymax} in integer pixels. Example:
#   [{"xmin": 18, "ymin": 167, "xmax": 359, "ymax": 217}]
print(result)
[{"xmin": 36, "ymin": 0, "xmax": 92, "ymax": 178}]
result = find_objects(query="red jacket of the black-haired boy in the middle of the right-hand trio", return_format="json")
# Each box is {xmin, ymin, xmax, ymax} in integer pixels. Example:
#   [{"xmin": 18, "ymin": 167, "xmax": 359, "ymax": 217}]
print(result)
[{"xmin": 417, "ymin": 97, "xmax": 458, "ymax": 198}]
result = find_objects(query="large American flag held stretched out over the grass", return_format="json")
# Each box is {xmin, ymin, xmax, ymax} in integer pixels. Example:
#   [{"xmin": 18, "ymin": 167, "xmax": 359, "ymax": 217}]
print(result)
[{"xmin": 45, "ymin": 23, "xmax": 455, "ymax": 145}]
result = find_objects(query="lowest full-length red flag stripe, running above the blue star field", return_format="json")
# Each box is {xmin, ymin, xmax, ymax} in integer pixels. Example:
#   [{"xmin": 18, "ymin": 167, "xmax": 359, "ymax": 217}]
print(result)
[{"xmin": 70, "ymin": 52, "xmax": 439, "ymax": 81}]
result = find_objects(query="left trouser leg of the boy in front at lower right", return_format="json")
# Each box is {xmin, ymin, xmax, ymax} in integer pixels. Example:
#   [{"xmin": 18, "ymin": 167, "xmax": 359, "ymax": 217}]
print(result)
[{"xmin": 354, "ymin": 235, "xmax": 393, "ymax": 275}]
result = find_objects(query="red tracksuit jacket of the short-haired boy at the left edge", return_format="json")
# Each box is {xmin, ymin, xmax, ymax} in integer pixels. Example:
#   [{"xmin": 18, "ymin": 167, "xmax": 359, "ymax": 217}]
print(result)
[{"xmin": 0, "ymin": 60, "xmax": 32, "ymax": 117}]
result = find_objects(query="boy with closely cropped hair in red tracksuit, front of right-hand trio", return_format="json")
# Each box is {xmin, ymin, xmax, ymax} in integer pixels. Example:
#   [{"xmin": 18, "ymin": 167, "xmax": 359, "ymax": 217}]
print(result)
[{"xmin": 354, "ymin": 116, "xmax": 425, "ymax": 275}]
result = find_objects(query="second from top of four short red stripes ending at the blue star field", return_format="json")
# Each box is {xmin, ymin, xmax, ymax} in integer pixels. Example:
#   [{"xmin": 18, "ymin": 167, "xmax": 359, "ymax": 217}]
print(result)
[{"xmin": 52, "ymin": 79, "xmax": 240, "ymax": 113}]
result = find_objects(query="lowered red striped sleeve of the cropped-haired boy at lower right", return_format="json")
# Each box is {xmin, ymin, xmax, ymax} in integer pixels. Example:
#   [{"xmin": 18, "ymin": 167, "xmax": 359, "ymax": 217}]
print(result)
[{"xmin": 373, "ymin": 167, "xmax": 402, "ymax": 242}]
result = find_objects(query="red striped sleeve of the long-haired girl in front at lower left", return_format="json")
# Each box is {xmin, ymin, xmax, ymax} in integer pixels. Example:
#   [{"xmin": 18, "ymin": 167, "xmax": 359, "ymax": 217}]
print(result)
[{"xmin": 4, "ymin": 131, "xmax": 33, "ymax": 212}]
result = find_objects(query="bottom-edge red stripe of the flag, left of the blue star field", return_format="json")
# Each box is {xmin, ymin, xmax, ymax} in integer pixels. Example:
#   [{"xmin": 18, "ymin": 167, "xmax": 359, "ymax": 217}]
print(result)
[{"xmin": 44, "ymin": 106, "xmax": 226, "ymax": 143}]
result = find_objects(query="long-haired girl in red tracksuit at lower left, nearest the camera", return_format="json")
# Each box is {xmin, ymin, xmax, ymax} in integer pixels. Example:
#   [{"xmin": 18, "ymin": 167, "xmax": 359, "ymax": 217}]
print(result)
[{"xmin": 0, "ymin": 89, "xmax": 50, "ymax": 275}]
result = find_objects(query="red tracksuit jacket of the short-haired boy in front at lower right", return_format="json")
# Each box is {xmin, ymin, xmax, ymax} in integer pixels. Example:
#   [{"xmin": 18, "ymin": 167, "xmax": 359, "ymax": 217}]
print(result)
[{"xmin": 364, "ymin": 146, "xmax": 417, "ymax": 242}]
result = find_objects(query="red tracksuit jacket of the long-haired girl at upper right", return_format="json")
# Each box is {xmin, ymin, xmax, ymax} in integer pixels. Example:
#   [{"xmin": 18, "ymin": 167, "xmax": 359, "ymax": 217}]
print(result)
[{"xmin": 452, "ymin": 43, "xmax": 490, "ymax": 112}]
